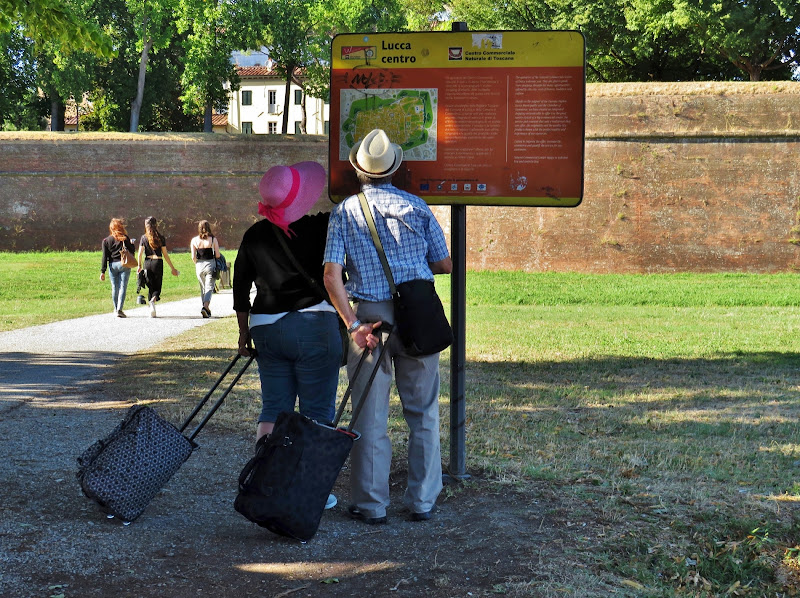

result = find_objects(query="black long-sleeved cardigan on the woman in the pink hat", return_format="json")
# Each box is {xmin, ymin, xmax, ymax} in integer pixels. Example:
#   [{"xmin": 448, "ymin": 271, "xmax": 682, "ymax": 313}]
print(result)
[{"xmin": 233, "ymin": 213, "xmax": 330, "ymax": 314}]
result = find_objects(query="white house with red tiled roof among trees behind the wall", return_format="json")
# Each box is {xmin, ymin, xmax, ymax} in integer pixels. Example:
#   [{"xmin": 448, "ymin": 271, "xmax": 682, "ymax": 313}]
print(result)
[{"xmin": 223, "ymin": 61, "xmax": 330, "ymax": 135}]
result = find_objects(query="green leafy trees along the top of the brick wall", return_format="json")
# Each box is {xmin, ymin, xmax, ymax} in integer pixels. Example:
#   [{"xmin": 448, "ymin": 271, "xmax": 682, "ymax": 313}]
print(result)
[{"xmin": 0, "ymin": 0, "xmax": 800, "ymax": 131}]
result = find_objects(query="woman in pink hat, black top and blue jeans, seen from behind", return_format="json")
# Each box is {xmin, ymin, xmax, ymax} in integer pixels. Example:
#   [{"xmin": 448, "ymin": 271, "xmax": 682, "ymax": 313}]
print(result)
[{"xmin": 233, "ymin": 162, "xmax": 342, "ymax": 508}]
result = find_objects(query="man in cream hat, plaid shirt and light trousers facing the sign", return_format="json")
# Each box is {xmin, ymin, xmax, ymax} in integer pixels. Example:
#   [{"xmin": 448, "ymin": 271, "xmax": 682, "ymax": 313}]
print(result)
[{"xmin": 324, "ymin": 129, "xmax": 453, "ymax": 524}]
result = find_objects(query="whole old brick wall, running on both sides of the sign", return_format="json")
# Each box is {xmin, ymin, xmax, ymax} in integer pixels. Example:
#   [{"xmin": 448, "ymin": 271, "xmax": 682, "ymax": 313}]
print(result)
[{"xmin": 0, "ymin": 82, "xmax": 800, "ymax": 272}]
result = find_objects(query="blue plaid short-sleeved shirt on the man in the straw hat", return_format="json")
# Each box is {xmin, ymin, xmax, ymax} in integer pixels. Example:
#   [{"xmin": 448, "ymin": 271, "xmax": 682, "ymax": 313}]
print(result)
[{"xmin": 324, "ymin": 184, "xmax": 450, "ymax": 301}]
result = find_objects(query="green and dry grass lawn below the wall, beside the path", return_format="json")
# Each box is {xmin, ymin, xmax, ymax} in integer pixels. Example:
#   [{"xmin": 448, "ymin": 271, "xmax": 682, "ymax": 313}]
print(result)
[{"xmin": 0, "ymin": 254, "xmax": 800, "ymax": 597}]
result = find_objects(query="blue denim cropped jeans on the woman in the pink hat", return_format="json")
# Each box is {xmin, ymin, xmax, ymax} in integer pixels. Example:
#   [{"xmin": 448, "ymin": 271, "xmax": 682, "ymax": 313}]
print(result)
[{"xmin": 250, "ymin": 311, "xmax": 342, "ymax": 422}]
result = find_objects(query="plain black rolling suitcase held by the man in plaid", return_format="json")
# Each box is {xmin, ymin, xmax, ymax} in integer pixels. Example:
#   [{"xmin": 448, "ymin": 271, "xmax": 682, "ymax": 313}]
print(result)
[{"xmin": 233, "ymin": 331, "xmax": 391, "ymax": 541}]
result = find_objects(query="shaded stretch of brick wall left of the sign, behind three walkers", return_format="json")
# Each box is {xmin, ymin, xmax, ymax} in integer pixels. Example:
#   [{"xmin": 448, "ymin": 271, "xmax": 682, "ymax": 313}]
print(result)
[{"xmin": 0, "ymin": 133, "xmax": 331, "ymax": 251}]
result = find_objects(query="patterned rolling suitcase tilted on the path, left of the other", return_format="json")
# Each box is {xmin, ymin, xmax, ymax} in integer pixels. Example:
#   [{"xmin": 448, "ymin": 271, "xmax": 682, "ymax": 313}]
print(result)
[{"xmin": 77, "ymin": 354, "xmax": 254, "ymax": 524}]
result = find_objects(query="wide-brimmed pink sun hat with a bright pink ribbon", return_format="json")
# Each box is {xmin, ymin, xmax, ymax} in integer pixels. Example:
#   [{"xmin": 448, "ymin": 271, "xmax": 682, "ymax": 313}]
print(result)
[{"xmin": 258, "ymin": 162, "xmax": 326, "ymax": 235}]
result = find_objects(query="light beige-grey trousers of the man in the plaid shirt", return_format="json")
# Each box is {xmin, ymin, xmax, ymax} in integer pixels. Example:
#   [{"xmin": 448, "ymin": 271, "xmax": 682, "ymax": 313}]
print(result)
[{"xmin": 347, "ymin": 301, "xmax": 442, "ymax": 517}]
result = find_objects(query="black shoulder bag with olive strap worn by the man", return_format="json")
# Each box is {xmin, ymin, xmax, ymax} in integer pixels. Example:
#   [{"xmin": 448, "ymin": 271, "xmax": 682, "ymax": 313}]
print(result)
[{"xmin": 358, "ymin": 193, "xmax": 453, "ymax": 356}]
